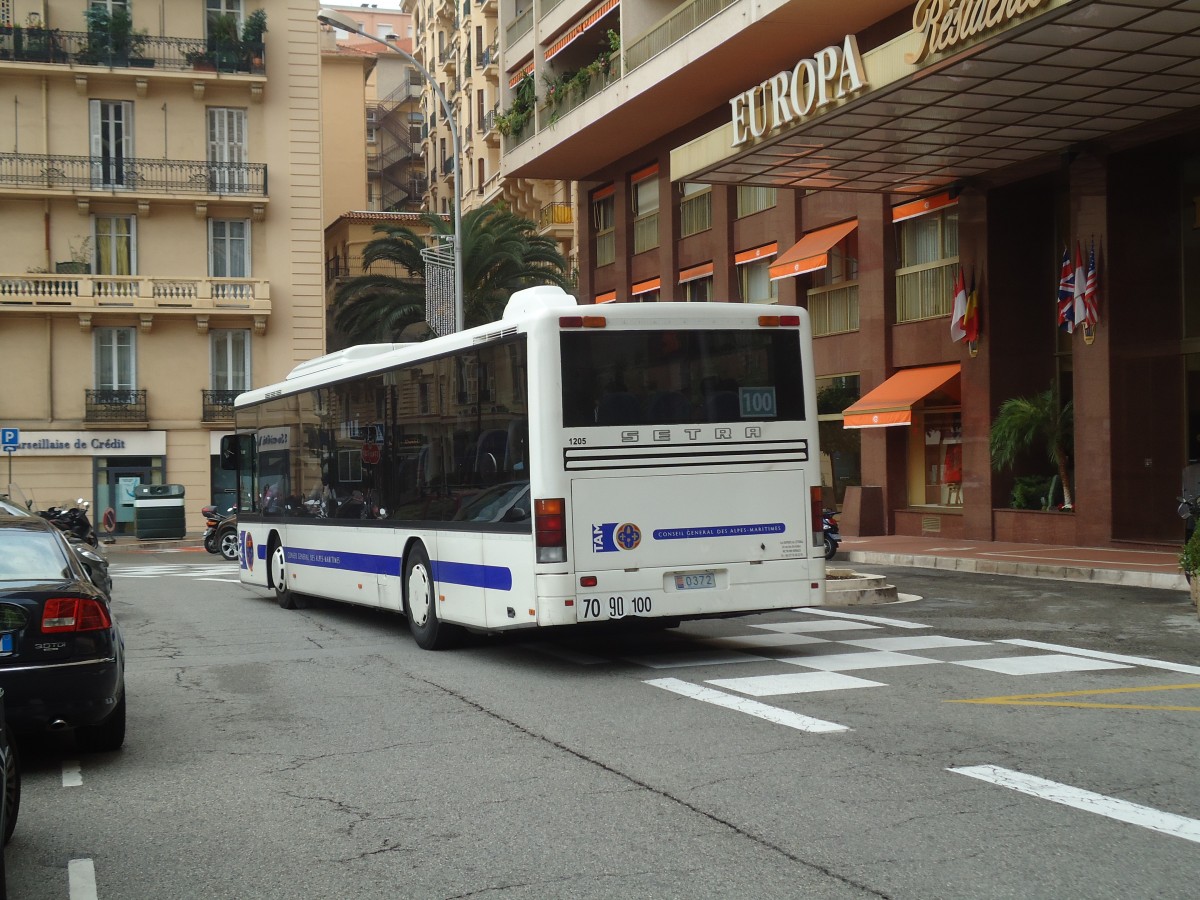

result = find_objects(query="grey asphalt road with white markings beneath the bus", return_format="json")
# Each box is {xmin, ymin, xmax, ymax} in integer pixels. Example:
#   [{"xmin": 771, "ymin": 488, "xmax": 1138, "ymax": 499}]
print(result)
[{"xmin": 7, "ymin": 553, "xmax": 1200, "ymax": 900}]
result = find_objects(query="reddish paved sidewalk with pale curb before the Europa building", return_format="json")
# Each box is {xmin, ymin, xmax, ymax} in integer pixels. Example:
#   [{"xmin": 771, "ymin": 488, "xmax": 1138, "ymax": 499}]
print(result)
[{"xmin": 832, "ymin": 535, "xmax": 1188, "ymax": 590}]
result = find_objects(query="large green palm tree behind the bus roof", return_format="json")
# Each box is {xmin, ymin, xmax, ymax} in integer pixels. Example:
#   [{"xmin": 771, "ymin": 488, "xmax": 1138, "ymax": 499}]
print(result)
[{"xmin": 332, "ymin": 205, "xmax": 571, "ymax": 341}]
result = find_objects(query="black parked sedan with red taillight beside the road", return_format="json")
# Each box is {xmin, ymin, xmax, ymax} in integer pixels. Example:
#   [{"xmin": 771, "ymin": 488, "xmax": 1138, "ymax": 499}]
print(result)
[{"xmin": 0, "ymin": 515, "xmax": 125, "ymax": 750}]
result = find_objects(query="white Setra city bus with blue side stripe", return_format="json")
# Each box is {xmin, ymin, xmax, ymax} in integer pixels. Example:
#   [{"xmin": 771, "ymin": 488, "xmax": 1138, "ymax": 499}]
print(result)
[{"xmin": 222, "ymin": 287, "xmax": 824, "ymax": 649}]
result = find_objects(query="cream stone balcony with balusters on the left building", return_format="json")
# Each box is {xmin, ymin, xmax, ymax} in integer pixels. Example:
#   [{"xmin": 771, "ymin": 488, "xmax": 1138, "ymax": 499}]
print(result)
[{"xmin": 0, "ymin": 272, "xmax": 271, "ymax": 334}]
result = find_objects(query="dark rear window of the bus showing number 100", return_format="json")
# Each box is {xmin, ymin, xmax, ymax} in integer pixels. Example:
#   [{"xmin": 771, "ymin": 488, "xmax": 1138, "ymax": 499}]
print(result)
[{"xmin": 560, "ymin": 329, "xmax": 804, "ymax": 428}]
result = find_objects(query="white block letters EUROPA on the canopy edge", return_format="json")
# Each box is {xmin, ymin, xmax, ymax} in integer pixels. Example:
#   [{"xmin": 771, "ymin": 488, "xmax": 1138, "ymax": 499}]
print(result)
[{"xmin": 730, "ymin": 34, "xmax": 864, "ymax": 146}]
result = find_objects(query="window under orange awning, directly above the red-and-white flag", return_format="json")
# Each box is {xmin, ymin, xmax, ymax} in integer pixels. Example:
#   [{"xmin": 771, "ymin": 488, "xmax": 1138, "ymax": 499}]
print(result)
[{"xmin": 896, "ymin": 206, "xmax": 959, "ymax": 322}]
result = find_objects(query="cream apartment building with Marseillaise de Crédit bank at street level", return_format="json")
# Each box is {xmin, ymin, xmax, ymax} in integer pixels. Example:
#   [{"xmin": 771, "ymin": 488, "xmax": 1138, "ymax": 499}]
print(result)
[{"xmin": 0, "ymin": 0, "xmax": 325, "ymax": 532}]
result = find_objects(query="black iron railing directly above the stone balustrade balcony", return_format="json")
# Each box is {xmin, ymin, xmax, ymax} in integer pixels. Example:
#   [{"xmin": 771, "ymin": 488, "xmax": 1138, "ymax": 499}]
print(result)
[{"xmin": 0, "ymin": 154, "xmax": 266, "ymax": 197}]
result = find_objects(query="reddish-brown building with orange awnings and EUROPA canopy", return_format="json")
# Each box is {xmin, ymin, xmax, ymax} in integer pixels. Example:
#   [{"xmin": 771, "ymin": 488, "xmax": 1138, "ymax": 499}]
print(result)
[{"xmin": 500, "ymin": 0, "xmax": 1200, "ymax": 545}]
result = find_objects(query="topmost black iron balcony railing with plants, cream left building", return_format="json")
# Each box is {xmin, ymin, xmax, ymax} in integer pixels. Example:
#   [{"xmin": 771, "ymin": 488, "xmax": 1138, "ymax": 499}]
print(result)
[{"xmin": 0, "ymin": 25, "xmax": 266, "ymax": 74}]
